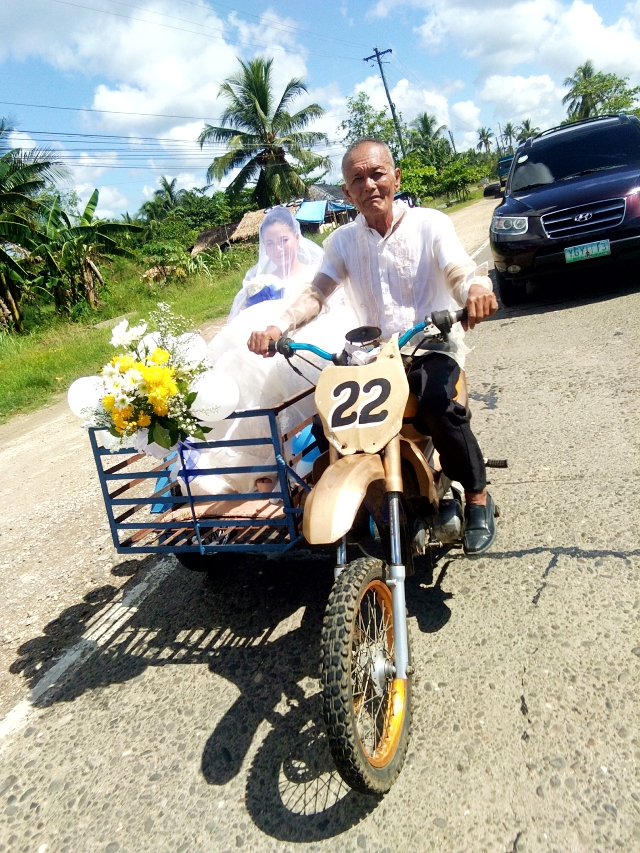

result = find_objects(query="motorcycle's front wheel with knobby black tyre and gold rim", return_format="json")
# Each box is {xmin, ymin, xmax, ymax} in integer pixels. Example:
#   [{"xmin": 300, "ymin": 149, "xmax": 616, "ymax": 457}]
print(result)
[{"xmin": 321, "ymin": 558, "xmax": 412, "ymax": 795}]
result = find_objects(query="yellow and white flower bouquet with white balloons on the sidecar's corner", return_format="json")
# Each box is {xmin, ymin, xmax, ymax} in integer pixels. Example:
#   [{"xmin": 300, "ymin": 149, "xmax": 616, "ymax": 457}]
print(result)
[{"xmin": 69, "ymin": 302, "xmax": 238, "ymax": 455}]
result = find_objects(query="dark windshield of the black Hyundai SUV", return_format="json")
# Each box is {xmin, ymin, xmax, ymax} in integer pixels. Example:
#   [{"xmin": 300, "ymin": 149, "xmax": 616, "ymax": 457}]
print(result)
[{"xmin": 509, "ymin": 122, "xmax": 640, "ymax": 192}]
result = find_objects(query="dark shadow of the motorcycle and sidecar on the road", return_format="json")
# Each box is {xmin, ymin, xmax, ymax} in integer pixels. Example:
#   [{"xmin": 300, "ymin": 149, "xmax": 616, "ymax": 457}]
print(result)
[{"xmin": 14, "ymin": 551, "xmax": 450, "ymax": 842}]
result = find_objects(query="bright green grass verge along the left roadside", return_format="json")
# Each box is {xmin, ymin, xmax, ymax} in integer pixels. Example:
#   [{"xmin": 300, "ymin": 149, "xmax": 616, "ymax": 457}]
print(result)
[{"xmin": 0, "ymin": 246, "xmax": 256, "ymax": 423}]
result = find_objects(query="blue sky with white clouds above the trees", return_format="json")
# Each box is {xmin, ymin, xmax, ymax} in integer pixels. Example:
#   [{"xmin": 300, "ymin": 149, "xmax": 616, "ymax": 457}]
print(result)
[{"xmin": 0, "ymin": 0, "xmax": 640, "ymax": 216}]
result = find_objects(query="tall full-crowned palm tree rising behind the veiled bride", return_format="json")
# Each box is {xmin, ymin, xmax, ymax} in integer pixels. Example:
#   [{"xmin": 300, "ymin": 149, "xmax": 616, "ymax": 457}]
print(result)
[{"xmin": 198, "ymin": 57, "xmax": 331, "ymax": 207}]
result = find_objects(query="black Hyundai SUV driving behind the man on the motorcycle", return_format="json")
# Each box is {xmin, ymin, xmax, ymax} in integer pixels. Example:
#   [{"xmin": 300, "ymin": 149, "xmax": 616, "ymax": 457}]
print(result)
[{"xmin": 490, "ymin": 115, "xmax": 640, "ymax": 305}]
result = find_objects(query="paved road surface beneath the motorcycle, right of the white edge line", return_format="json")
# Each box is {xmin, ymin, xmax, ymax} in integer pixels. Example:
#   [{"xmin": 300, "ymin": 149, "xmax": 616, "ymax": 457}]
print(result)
[{"xmin": 0, "ymin": 250, "xmax": 640, "ymax": 853}]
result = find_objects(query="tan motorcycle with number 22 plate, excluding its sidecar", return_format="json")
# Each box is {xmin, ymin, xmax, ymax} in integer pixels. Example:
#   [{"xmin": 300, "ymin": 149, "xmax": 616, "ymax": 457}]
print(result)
[{"xmin": 270, "ymin": 310, "xmax": 506, "ymax": 794}]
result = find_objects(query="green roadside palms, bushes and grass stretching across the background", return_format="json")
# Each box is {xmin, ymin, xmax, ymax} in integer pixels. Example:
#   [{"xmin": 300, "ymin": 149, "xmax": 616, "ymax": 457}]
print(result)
[{"xmin": 0, "ymin": 58, "xmax": 640, "ymax": 421}]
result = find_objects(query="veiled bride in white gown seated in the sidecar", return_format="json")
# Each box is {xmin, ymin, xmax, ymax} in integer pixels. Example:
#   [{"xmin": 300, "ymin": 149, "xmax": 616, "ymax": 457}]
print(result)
[{"xmin": 189, "ymin": 207, "xmax": 358, "ymax": 494}]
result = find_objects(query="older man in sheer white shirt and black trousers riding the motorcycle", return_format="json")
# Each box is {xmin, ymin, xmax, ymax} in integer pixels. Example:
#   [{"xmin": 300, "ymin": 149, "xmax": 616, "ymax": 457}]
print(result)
[{"xmin": 248, "ymin": 139, "xmax": 498, "ymax": 556}]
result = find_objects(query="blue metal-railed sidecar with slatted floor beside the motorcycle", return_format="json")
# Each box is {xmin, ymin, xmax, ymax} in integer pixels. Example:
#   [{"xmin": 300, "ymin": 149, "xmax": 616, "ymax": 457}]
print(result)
[{"xmin": 89, "ymin": 388, "xmax": 317, "ymax": 554}]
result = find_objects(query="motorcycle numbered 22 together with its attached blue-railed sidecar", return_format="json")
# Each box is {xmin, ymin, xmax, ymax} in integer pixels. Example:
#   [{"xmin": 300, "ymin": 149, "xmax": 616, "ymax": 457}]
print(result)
[{"xmin": 89, "ymin": 311, "xmax": 506, "ymax": 795}]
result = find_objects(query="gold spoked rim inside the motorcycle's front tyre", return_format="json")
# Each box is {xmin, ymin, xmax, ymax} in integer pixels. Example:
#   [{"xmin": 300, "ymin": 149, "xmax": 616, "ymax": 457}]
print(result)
[{"xmin": 351, "ymin": 579, "xmax": 406, "ymax": 768}]
